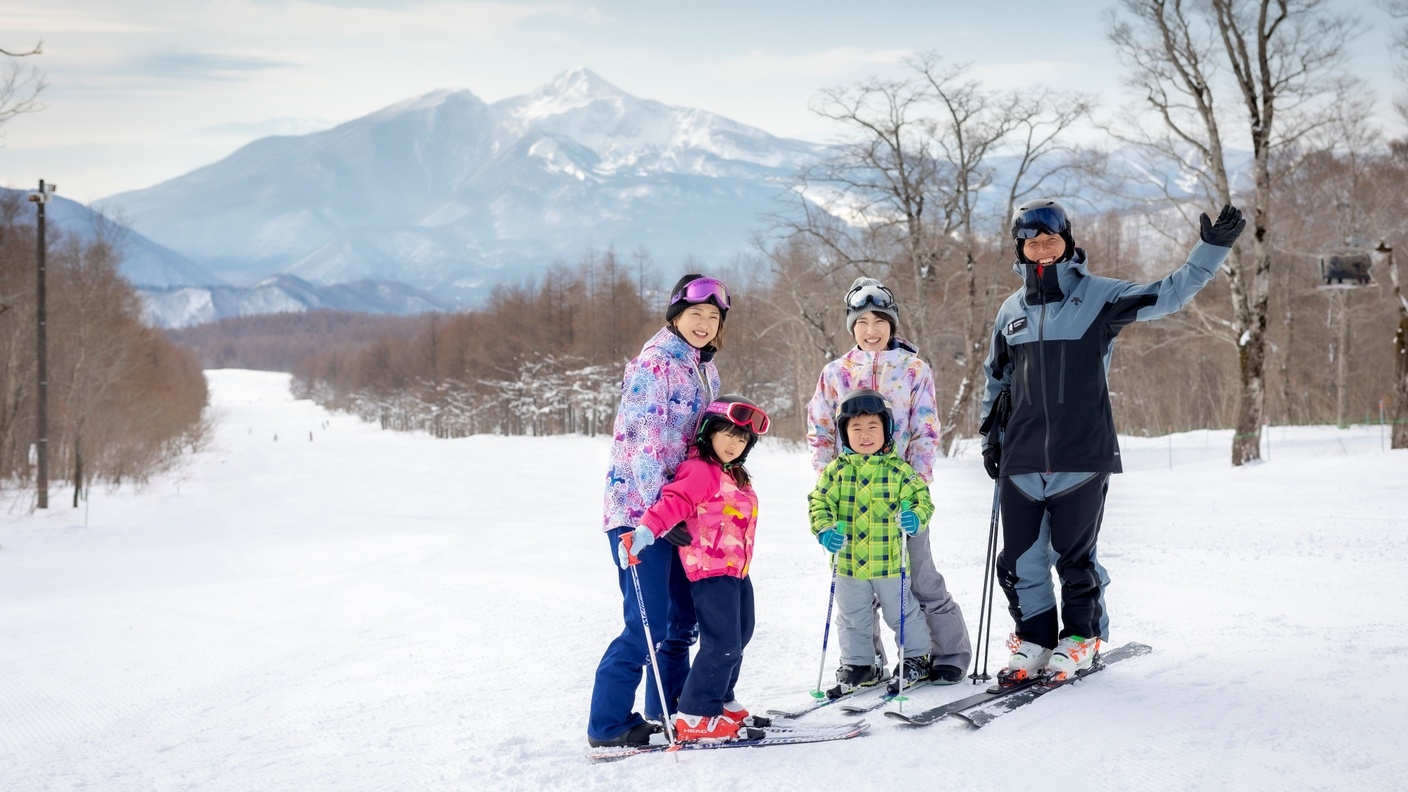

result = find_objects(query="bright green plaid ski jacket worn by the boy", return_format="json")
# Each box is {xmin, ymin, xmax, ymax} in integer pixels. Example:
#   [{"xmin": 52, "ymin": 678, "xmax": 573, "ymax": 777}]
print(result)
[{"xmin": 807, "ymin": 451, "xmax": 934, "ymax": 572}]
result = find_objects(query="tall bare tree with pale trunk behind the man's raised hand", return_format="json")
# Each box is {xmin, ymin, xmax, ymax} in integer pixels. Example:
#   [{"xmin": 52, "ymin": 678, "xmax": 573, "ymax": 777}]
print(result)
[{"xmin": 1110, "ymin": 0, "xmax": 1359, "ymax": 465}]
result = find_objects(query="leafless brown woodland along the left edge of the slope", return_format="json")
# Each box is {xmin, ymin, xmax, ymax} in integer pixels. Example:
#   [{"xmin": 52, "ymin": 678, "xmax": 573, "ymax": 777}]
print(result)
[{"xmin": 0, "ymin": 192, "xmax": 207, "ymax": 506}]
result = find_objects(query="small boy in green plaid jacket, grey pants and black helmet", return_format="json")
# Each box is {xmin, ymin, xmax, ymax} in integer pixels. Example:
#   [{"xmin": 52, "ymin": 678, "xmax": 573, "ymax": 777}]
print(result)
[{"xmin": 808, "ymin": 388, "xmax": 934, "ymax": 698}]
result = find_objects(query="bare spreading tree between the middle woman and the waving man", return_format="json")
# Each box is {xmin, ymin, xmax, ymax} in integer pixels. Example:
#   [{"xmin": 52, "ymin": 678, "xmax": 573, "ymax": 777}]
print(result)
[{"xmin": 783, "ymin": 54, "xmax": 1091, "ymax": 450}]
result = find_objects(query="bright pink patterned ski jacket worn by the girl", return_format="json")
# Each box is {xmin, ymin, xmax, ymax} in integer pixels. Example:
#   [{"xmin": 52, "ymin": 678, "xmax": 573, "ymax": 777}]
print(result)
[{"xmin": 641, "ymin": 450, "xmax": 758, "ymax": 582}]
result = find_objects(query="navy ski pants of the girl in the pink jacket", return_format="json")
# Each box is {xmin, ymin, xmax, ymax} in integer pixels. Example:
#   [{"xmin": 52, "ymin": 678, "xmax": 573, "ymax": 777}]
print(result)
[{"xmin": 680, "ymin": 575, "xmax": 753, "ymax": 717}]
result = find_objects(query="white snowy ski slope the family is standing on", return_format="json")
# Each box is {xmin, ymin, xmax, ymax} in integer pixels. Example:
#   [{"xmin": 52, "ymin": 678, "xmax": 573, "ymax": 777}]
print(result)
[{"xmin": 0, "ymin": 371, "xmax": 1408, "ymax": 791}]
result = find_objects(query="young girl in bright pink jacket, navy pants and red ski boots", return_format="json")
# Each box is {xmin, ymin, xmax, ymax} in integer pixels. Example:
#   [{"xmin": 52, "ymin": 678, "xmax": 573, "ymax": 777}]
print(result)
[{"xmin": 618, "ymin": 396, "xmax": 769, "ymax": 740}]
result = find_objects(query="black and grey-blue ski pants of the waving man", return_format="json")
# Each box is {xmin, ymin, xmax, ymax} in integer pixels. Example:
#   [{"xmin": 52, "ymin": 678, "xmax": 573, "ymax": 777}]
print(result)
[{"xmin": 997, "ymin": 474, "xmax": 1110, "ymax": 648}]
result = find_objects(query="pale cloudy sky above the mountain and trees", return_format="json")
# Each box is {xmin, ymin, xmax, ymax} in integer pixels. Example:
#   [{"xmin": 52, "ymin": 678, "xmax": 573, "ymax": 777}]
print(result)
[{"xmin": 0, "ymin": 0, "xmax": 1395, "ymax": 203}]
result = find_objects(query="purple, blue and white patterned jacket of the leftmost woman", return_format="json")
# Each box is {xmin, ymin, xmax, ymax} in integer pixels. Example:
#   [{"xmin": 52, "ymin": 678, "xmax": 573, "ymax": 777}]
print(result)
[{"xmin": 601, "ymin": 327, "xmax": 718, "ymax": 531}]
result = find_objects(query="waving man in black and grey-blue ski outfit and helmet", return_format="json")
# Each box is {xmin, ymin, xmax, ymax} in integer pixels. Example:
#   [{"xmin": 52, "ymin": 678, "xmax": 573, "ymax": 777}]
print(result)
[{"xmin": 983, "ymin": 199, "xmax": 1246, "ymax": 683}]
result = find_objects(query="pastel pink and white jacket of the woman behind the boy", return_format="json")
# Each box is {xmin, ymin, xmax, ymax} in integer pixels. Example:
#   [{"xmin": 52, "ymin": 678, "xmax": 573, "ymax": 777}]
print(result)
[{"xmin": 807, "ymin": 338, "xmax": 939, "ymax": 483}]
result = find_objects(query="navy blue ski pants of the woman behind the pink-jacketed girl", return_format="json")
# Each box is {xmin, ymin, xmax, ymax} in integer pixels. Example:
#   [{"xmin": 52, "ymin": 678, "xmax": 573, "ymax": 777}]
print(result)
[{"xmin": 587, "ymin": 527, "xmax": 694, "ymax": 740}]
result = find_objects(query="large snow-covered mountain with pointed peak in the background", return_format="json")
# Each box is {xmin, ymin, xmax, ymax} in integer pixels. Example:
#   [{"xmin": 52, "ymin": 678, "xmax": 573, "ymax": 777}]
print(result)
[{"xmin": 100, "ymin": 69, "xmax": 822, "ymax": 303}]
